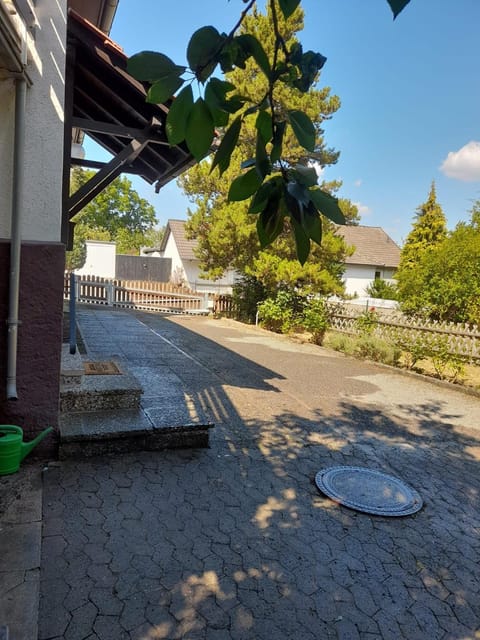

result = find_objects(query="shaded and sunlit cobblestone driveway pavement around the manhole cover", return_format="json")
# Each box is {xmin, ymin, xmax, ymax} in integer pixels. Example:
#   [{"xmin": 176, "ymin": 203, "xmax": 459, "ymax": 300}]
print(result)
[{"xmin": 39, "ymin": 311, "xmax": 480, "ymax": 640}]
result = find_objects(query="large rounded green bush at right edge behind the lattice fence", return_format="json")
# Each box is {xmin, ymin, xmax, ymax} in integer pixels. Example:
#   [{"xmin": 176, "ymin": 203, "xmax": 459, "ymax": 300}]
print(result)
[{"xmin": 399, "ymin": 202, "xmax": 480, "ymax": 324}]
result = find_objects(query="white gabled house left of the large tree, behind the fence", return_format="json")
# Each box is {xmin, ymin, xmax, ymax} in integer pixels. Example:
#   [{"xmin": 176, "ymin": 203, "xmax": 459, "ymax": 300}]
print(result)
[{"xmin": 156, "ymin": 220, "xmax": 237, "ymax": 293}]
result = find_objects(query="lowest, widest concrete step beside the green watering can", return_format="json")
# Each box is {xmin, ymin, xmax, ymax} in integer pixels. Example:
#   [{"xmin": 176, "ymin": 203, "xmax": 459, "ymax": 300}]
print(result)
[{"xmin": 59, "ymin": 408, "xmax": 213, "ymax": 460}]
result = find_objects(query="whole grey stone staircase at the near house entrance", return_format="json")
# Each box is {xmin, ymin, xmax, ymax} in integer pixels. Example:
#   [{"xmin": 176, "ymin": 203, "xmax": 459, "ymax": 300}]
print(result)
[{"xmin": 59, "ymin": 345, "xmax": 213, "ymax": 459}]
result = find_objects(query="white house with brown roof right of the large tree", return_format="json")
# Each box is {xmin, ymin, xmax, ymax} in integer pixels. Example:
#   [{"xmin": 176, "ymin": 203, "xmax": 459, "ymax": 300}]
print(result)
[{"xmin": 337, "ymin": 225, "xmax": 400, "ymax": 297}]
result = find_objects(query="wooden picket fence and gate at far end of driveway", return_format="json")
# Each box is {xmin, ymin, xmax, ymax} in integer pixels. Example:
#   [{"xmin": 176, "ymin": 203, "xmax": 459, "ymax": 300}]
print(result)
[{"xmin": 64, "ymin": 274, "xmax": 213, "ymax": 314}]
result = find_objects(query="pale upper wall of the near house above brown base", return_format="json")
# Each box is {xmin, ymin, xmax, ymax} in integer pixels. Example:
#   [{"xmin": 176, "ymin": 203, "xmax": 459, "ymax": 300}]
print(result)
[{"xmin": 0, "ymin": 0, "xmax": 66, "ymax": 242}]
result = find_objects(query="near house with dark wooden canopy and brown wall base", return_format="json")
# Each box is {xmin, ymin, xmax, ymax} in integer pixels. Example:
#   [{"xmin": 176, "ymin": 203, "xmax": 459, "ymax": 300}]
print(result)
[{"xmin": 0, "ymin": 0, "xmax": 194, "ymax": 446}]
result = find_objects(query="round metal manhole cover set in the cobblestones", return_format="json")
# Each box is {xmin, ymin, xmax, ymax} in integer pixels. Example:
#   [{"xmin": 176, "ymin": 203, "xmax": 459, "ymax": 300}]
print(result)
[{"xmin": 315, "ymin": 467, "xmax": 423, "ymax": 516}]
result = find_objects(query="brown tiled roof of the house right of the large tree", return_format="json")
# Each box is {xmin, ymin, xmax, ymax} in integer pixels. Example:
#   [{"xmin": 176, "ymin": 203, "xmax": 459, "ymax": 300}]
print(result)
[{"xmin": 337, "ymin": 225, "xmax": 400, "ymax": 268}]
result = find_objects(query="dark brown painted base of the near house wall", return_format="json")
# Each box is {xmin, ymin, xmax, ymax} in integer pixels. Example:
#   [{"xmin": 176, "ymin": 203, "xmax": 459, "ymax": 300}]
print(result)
[{"xmin": 0, "ymin": 240, "xmax": 65, "ymax": 456}]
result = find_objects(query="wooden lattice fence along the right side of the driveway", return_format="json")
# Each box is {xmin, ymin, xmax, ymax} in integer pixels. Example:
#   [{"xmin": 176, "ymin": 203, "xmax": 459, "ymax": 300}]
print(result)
[{"xmin": 330, "ymin": 304, "xmax": 480, "ymax": 360}]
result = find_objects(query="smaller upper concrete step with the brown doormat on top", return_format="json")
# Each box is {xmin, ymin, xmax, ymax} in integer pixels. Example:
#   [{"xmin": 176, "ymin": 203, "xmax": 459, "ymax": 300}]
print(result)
[{"xmin": 60, "ymin": 367, "xmax": 143, "ymax": 413}]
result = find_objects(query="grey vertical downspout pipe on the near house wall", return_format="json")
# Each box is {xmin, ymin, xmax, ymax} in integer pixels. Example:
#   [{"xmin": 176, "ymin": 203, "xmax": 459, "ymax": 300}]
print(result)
[{"xmin": 7, "ymin": 77, "xmax": 27, "ymax": 400}]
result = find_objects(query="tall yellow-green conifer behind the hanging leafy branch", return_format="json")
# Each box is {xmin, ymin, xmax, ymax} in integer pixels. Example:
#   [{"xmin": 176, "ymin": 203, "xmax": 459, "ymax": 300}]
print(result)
[{"xmin": 180, "ymin": 4, "xmax": 358, "ymax": 293}]
